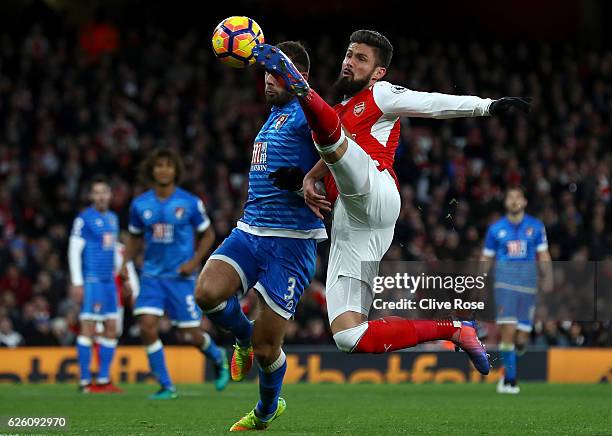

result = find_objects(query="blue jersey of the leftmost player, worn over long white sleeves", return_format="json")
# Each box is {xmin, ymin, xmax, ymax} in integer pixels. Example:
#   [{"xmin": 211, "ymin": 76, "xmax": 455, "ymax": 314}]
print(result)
[{"xmin": 71, "ymin": 207, "xmax": 119, "ymax": 282}]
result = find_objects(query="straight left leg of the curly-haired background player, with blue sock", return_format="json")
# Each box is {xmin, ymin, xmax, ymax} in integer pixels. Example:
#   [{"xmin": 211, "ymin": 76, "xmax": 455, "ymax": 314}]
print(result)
[{"xmin": 138, "ymin": 314, "xmax": 177, "ymax": 400}]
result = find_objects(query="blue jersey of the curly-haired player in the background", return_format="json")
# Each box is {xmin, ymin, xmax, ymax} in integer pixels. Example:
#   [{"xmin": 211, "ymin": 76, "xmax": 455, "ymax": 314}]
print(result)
[{"xmin": 129, "ymin": 188, "xmax": 210, "ymax": 278}]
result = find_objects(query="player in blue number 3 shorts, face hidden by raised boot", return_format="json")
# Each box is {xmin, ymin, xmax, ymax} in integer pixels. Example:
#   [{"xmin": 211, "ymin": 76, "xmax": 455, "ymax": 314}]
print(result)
[{"xmin": 196, "ymin": 42, "xmax": 327, "ymax": 431}]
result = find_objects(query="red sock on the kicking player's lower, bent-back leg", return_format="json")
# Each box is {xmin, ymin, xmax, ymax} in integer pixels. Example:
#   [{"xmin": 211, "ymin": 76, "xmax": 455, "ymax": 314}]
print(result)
[{"xmin": 353, "ymin": 316, "xmax": 459, "ymax": 353}]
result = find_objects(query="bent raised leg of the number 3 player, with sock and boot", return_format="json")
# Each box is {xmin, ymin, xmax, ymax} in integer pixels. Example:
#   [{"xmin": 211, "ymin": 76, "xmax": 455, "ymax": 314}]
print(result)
[{"xmin": 195, "ymin": 258, "xmax": 253, "ymax": 381}]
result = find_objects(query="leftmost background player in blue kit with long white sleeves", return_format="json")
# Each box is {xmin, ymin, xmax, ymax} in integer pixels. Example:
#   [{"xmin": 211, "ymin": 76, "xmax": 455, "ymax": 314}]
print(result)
[{"xmin": 68, "ymin": 177, "xmax": 126, "ymax": 393}]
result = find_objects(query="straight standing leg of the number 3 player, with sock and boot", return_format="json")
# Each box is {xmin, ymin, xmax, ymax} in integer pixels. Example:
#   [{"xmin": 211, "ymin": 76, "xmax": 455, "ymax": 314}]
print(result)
[{"xmin": 230, "ymin": 295, "xmax": 287, "ymax": 431}]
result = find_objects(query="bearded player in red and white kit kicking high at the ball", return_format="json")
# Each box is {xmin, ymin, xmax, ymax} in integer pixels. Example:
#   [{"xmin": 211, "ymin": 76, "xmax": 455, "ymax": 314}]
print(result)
[{"xmin": 254, "ymin": 30, "xmax": 530, "ymax": 374}]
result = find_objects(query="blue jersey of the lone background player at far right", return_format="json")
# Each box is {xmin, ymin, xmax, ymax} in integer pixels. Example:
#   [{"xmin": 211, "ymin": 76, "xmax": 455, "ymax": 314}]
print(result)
[{"xmin": 483, "ymin": 215, "xmax": 548, "ymax": 292}]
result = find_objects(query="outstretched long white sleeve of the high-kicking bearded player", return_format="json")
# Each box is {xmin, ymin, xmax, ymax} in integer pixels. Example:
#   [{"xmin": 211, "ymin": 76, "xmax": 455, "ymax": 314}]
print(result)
[{"xmin": 373, "ymin": 82, "xmax": 493, "ymax": 119}]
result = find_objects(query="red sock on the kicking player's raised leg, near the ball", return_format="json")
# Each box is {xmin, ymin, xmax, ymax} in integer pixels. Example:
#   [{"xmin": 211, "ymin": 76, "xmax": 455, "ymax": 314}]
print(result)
[{"xmin": 299, "ymin": 88, "xmax": 342, "ymax": 146}]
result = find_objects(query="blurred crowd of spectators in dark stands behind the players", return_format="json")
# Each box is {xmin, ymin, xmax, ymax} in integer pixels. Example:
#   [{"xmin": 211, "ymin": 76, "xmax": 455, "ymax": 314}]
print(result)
[{"xmin": 0, "ymin": 0, "xmax": 612, "ymax": 362}]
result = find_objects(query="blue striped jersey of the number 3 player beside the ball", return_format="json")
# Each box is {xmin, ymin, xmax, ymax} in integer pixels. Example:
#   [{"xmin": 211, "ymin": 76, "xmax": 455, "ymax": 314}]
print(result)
[{"xmin": 237, "ymin": 99, "xmax": 327, "ymax": 239}]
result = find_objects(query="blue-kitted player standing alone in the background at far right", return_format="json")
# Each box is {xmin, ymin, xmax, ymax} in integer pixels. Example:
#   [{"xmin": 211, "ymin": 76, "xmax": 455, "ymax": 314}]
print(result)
[{"xmin": 481, "ymin": 188, "xmax": 552, "ymax": 394}]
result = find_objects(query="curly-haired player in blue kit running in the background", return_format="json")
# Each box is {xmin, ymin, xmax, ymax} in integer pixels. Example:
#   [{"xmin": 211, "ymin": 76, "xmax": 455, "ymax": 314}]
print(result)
[{"xmin": 122, "ymin": 149, "xmax": 229, "ymax": 399}]
